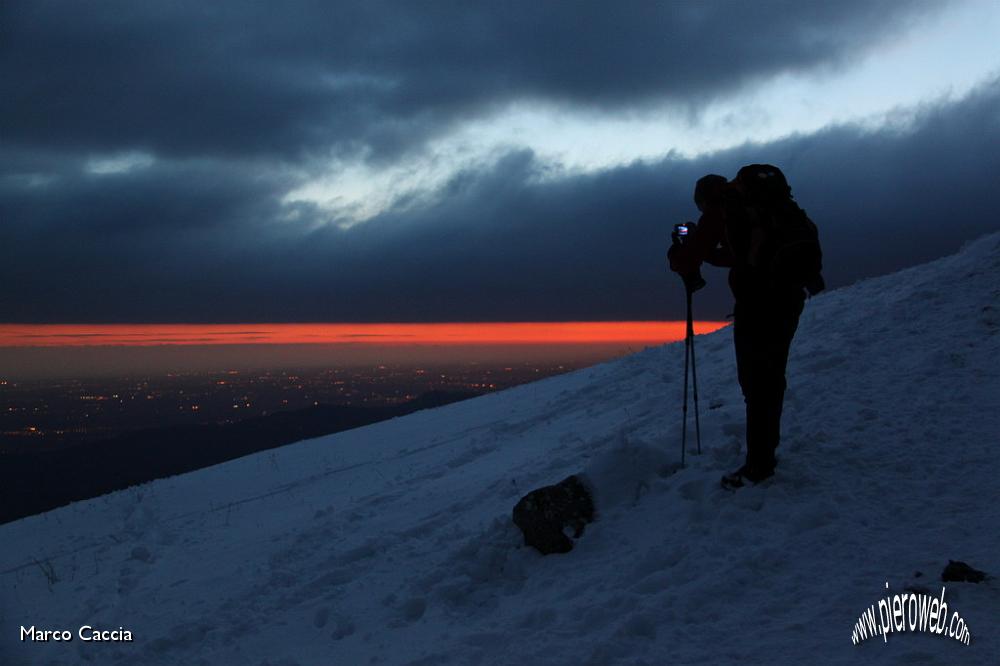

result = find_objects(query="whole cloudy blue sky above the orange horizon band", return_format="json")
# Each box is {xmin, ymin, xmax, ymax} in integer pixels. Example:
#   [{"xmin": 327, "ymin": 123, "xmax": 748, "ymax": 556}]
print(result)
[{"xmin": 0, "ymin": 0, "xmax": 1000, "ymax": 323}]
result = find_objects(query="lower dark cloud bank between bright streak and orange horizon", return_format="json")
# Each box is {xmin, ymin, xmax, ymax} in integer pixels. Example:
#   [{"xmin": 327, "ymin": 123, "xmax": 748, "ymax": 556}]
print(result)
[{"xmin": 0, "ymin": 80, "xmax": 1000, "ymax": 321}]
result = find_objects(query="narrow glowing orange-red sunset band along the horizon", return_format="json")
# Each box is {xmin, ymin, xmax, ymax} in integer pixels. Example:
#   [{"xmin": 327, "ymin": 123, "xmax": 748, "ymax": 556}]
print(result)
[{"xmin": 0, "ymin": 321, "xmax": 727, "ymax": 347}]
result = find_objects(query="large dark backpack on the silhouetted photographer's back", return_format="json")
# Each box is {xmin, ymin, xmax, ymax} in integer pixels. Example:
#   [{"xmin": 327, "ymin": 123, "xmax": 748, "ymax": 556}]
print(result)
[{"xmin": 736, "ymin": 164, "xmax": 826, "ymax": 296}]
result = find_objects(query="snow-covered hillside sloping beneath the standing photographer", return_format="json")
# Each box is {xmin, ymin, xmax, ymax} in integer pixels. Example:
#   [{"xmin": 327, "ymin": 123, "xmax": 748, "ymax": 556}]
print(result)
[{"xmin": 0, "ymin": 234, "xmax": 1000, "ymax": 666}]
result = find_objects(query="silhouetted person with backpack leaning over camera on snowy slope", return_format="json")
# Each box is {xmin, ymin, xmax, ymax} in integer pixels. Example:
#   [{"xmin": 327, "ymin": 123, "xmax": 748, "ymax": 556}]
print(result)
[{"xmin": 668, "ymin": 164, "xmax": 825, "ymax": 488}]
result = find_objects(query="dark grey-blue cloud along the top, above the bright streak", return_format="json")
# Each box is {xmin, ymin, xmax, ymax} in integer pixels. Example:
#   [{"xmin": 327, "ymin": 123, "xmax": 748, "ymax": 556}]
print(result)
[{"xmin": 0, "ymin": 0, "xmax": 930, "ymax": 159}]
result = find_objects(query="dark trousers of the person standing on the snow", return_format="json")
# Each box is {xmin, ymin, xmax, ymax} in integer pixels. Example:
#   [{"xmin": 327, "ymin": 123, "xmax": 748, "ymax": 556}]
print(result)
[{"xmin": 733, "ymin": 294, "xmax": 804, "ymax": 470}]
